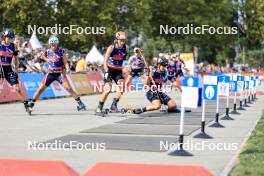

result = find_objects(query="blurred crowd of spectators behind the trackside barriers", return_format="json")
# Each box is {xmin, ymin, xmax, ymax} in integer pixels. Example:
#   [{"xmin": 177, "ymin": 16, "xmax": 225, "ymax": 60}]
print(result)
[{"xmin": 14, "ymin": 37, "xmax": 264, "ymax": 74}]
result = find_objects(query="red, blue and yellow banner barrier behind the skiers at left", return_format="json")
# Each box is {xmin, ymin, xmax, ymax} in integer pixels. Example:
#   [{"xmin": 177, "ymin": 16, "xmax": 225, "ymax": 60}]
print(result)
[{"xmin": 0, "ymin": 73, "xmax": 103, "ymax": 103}]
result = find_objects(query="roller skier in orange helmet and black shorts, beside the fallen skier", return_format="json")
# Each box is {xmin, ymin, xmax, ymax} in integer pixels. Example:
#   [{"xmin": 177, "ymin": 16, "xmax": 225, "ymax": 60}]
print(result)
[{"xmin": 96, "ymin": 31, "xmax": 129, "ymax": 113}]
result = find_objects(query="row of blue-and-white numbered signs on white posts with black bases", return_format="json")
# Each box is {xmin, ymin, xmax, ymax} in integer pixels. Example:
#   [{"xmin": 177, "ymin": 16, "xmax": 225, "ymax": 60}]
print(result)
[{"xmin": 169, "ymin": 73, "xmax": 264, "ymax": 156}]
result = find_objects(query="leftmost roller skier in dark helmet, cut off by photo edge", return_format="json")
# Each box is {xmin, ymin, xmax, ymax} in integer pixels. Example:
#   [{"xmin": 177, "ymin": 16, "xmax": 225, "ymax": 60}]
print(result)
[{"xmin": 0, "ymin": 29, "xmax": 28, "ymax": 110}]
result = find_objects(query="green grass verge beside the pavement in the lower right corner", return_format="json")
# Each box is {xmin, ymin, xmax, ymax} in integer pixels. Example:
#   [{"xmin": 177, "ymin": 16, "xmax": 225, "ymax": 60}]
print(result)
[{"xmin": 229, "ymin": 111, "xmax": 264, "ymax": 176}]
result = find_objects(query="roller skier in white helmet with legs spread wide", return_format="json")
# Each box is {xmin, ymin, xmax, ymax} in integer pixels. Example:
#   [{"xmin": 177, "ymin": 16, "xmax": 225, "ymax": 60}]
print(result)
[{"xmin": 29, "ymin": 36, "xmax": 85, "ymax": 110}]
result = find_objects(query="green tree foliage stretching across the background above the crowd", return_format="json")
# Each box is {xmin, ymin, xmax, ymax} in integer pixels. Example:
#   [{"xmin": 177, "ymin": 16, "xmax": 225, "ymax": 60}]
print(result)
[{"xmin": 0, "ymin": 0, "xmax": 264, "ymax": 63}]
